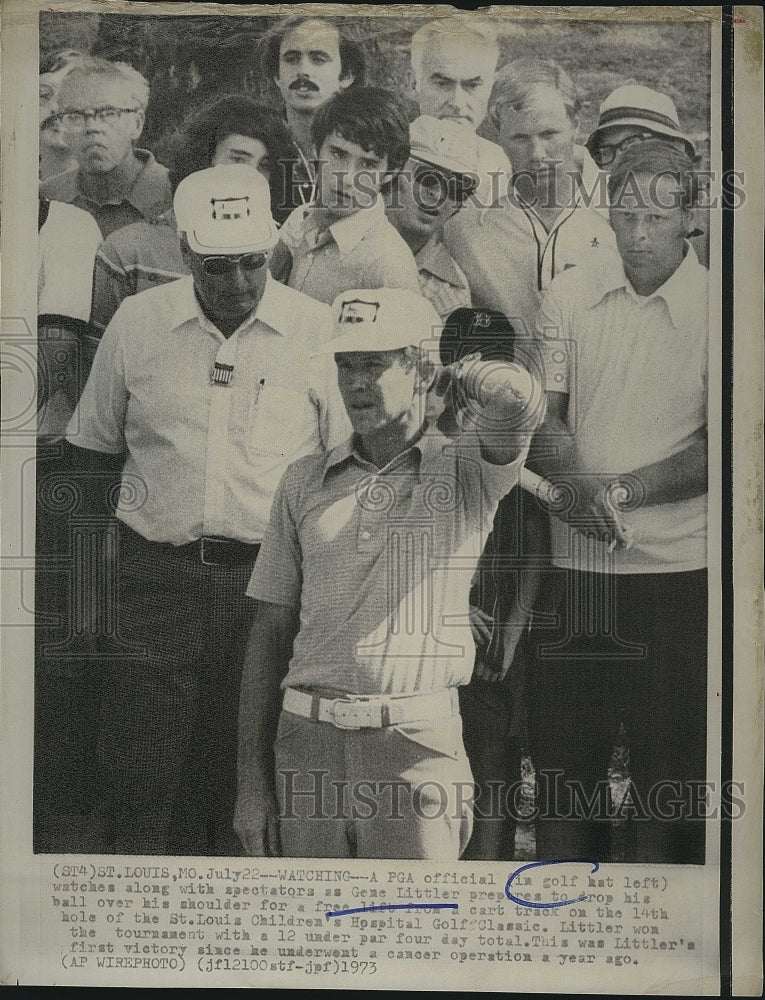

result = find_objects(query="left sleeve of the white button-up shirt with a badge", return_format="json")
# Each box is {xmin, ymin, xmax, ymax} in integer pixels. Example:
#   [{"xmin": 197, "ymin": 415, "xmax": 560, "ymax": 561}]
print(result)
[{"xmin": 66, "ymin": 298, "xmax": 130, "ymax": 455}]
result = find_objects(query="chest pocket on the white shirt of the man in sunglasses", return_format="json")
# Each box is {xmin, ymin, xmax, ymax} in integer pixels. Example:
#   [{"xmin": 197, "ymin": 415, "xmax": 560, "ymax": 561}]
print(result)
[{"xmin": 246, "ymin": 384, "xmax": 320, "ymax": 459}]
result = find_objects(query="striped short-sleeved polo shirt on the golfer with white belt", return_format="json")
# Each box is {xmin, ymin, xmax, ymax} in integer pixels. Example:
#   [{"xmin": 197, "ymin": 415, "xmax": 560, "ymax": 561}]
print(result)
[{"xmin": 247, "ymin": 425, "xmax": 526, "ymax": 695}]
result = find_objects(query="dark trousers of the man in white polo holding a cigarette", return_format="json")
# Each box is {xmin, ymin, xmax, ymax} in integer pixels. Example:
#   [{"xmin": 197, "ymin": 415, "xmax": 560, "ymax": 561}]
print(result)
[{"xmin": 526, "ymin": 570, "xmax": 707, "ymax": 864}]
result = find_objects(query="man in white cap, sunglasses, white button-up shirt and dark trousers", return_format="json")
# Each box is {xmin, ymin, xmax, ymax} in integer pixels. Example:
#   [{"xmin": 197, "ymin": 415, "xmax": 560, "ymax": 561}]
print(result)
[{"xmin": 68, "ymin": 164, "xmax": 348, "ymax": 855}]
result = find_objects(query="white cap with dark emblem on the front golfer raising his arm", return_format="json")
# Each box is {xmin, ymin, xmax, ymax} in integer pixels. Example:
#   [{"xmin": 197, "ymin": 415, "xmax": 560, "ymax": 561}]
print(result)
[{"xmin": 322, "ymin": 288, "xmax": 443, "ymax": 354}]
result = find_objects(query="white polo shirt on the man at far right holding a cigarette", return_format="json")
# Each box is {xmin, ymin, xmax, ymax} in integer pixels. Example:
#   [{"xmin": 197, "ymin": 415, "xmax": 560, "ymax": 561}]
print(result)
[{"xmin": 537, "ymin": 244, "xmax": 709, "ymax": 573}]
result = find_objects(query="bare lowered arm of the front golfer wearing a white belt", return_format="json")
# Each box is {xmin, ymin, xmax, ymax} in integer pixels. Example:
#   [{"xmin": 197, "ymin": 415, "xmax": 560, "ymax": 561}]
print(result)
[{"xmin": 234, "ymin": 601, "xmax": 299, "ymax": 857}]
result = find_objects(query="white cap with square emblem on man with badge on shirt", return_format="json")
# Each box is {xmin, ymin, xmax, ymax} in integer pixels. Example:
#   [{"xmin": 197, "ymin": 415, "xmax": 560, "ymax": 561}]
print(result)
[{"xmin": 173, "ymin": 163, "xmax": 279, "ymax": 254}]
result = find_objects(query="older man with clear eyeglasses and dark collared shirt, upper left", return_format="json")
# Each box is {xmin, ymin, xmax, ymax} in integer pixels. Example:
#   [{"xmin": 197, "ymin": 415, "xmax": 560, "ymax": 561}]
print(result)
[{"xmin": 41, "ymin": 56, "xmax": 172, "ymax": 238}]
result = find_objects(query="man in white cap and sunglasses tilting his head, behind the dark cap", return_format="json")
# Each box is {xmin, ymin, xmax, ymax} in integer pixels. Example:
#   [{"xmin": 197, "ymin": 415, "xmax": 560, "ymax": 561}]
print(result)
[{"xmin": 385, "ymin": 115, "xmax": 478, "ymax": 319}]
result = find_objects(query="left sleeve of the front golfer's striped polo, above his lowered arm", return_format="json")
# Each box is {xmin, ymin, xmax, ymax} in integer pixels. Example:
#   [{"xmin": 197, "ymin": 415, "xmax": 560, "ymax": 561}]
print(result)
[{"xmin": 247, "ymin": 465, "xmax": 303, "ymax": 609}]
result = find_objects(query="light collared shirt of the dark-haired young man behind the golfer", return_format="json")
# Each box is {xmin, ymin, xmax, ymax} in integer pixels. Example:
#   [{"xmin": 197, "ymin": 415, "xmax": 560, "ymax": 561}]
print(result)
[{"xmin": 279, "ymin": 197, "xmax": 420, "ymax": 304}]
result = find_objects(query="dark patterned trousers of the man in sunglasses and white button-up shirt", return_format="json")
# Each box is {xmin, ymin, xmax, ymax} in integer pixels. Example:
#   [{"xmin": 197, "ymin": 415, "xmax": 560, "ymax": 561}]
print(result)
[{"xmin": 98, "ymin": 528, "xmax": 255, "ymax": 855}]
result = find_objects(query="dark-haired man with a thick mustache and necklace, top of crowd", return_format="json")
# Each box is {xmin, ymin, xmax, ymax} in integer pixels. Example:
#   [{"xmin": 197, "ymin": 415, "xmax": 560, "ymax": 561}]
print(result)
[{"xmin": 261, "ymin": 17, "xmax": 365, "ymax": 223}]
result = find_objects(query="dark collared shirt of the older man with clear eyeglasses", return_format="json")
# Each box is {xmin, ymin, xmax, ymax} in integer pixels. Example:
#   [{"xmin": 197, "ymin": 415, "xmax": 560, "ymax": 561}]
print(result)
[{"xmin": 40, "ymin": 149, "xmax": 173, "ymax": 238}]
